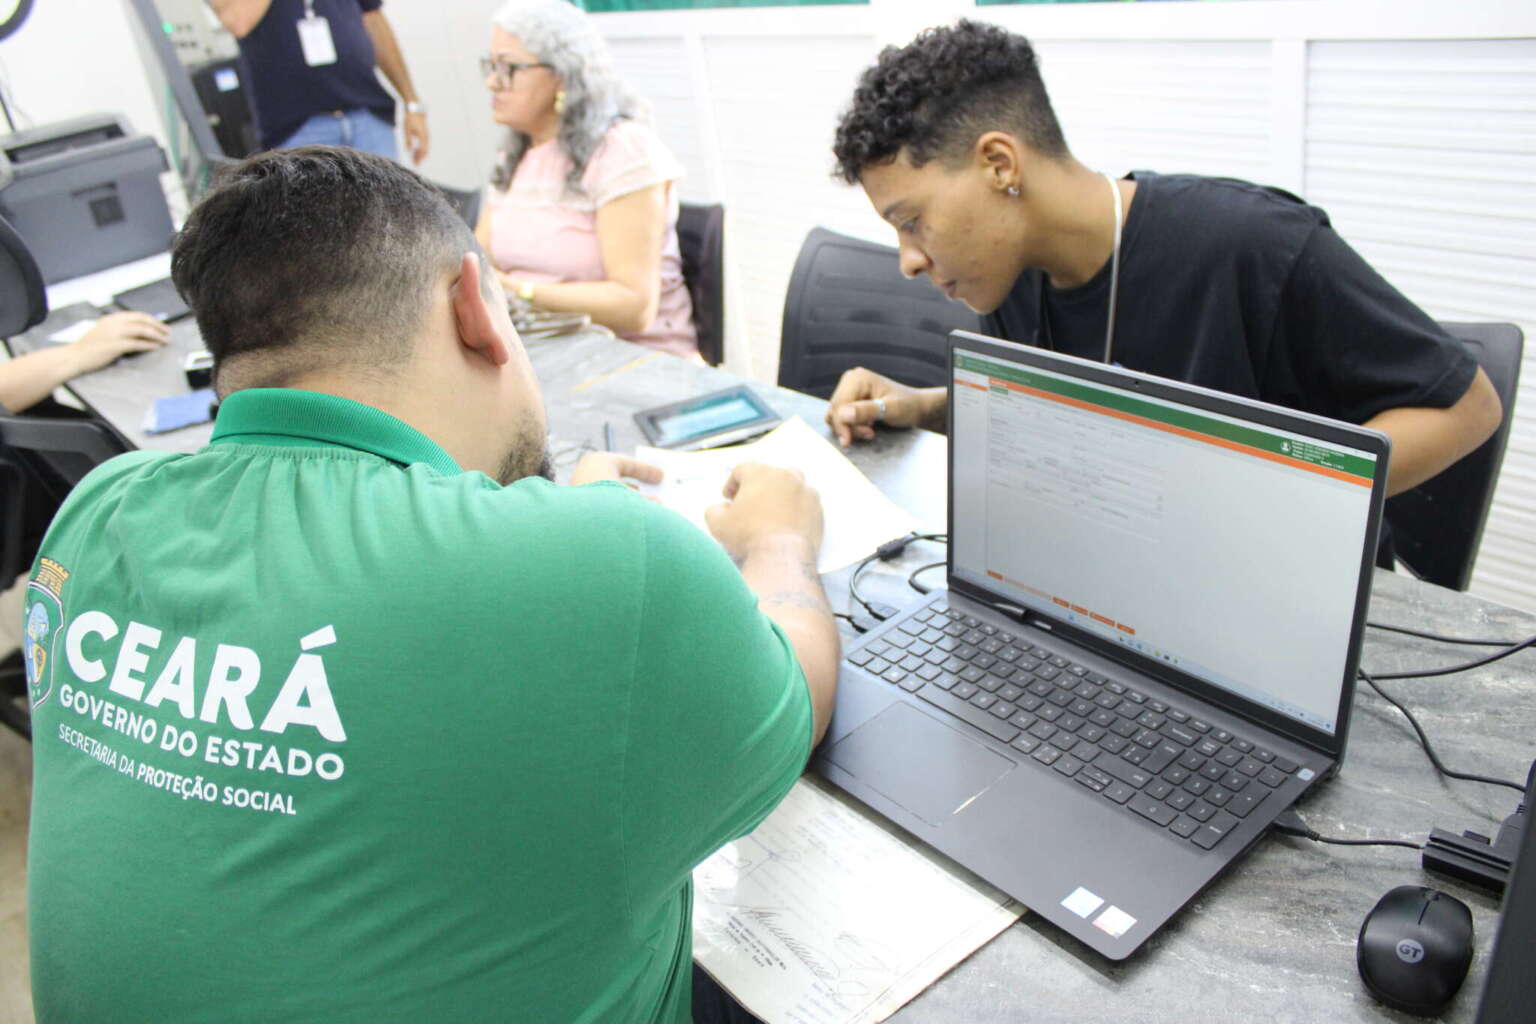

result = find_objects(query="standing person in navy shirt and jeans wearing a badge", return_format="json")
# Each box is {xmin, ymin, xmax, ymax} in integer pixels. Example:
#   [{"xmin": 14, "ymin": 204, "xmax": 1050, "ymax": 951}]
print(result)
[{"xmin": 207, "ymin": 0, "xmax": 427, "ymax": 164}]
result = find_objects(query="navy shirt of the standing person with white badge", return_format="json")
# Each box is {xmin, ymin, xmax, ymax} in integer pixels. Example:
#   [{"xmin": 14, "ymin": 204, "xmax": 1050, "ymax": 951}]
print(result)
[{"xmin": 240, "ymin": 0, "xmax": 395, "ymax": 149}]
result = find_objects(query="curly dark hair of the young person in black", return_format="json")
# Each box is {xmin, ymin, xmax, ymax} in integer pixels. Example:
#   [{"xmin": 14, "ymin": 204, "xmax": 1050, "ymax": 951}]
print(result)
[{"xmin": 833, "ymin": 20, "xmax": 1068, "ymax": 184}]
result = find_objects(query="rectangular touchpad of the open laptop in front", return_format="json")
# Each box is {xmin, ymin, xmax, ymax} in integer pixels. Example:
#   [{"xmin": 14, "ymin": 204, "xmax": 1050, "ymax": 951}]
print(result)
[{"xmin": 826, "ymin": 703, "xmax": 1014, "ymax": 827}]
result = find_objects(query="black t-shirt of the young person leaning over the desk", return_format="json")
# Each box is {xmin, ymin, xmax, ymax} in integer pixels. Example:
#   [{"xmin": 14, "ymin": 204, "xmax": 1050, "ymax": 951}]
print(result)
[{"xmin": 983, "ymin": 170, "xmax": 1478, "ymax": 424}]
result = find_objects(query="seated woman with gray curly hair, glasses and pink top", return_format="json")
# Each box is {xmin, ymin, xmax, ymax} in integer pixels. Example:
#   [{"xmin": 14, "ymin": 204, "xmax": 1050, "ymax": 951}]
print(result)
[{"xmin": 475, "ymin": 0, "xmax": 699, "ymax": 359}]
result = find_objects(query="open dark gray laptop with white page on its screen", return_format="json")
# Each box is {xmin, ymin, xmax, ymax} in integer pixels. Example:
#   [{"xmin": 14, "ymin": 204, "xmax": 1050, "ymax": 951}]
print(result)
[{"xmin": 814, "ymin": 332, "xmax": 1390, "ymax": 960}]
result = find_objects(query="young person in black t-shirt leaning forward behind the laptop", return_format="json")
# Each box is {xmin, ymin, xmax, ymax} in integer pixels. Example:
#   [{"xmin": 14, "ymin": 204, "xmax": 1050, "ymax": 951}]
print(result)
[{"xmin": 826, "ymin": 21, "xmax": 1501, "ymax": 493}]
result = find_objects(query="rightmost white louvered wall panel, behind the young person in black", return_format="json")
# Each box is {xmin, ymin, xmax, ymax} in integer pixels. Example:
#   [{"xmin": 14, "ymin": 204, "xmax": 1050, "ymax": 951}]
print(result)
[{"xmin": 1306, "ymin": 40, "xmax": 1536, "ymax": 608}]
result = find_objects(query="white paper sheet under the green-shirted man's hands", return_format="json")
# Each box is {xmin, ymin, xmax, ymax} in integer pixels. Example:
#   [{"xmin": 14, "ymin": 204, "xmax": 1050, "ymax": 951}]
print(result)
[{"xmin": 634, "ymin": 418, "xmax": 919, "ymax": 573}]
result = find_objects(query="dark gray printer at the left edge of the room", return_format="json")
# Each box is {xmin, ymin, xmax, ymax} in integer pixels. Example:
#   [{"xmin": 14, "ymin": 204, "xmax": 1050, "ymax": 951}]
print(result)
[{"xmin": 0, "ymin": 114, "xmax": 175, "ymax": 284}]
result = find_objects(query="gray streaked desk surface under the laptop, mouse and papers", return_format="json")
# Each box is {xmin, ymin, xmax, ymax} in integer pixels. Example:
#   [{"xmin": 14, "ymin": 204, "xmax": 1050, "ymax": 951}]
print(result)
[{"xmin": 17, "ymin": 307, "xmax": 1536, "ymax": 1024}]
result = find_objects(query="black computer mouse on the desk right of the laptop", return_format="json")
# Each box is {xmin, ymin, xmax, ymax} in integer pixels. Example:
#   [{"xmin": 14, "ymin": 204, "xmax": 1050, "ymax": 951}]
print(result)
[{"xmin": 1355, "ymin": 886, "xmax": 1471, "ymax": 1016}]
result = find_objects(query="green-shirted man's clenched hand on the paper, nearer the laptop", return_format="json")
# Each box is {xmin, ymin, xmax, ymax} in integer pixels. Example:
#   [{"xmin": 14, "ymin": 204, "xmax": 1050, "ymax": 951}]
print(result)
[{"xmin": 703, "ymin": 462, "xmax": 822, "ymax": 567}]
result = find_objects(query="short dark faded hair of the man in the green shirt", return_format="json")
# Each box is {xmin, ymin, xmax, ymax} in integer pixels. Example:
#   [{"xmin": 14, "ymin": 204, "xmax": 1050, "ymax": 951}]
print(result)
[{"xmin": 170, "ymin": 146, "xmax": 479, "ymax": 391}]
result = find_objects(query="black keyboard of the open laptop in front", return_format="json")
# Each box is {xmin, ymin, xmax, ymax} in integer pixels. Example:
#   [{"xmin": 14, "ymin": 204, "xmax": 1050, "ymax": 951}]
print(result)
[{"xmin": 848, "ymin": 593, "xmax": 1299, "ymax": 851}]
